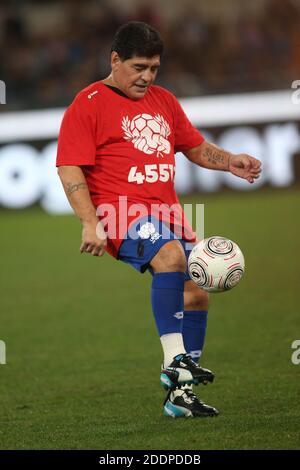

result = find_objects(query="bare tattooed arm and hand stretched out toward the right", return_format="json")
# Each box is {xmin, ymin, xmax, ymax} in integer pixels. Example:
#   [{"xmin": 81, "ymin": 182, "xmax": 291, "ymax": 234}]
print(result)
[{"xmin": 184, "ymin": 141, "xmax": 261, "ymax": 183}]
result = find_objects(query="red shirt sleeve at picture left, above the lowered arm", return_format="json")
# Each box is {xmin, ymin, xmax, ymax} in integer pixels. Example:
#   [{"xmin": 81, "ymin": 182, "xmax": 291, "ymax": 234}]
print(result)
[{"xmin": 56, "ymin": 94, "xmax": 97, "ymax": 166}]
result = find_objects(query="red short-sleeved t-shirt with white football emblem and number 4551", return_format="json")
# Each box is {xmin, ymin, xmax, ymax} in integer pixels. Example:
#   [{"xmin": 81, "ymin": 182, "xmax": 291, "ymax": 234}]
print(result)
[{"xmin": 56, "ymin": 81, "xmax": 204, "ymax": 257}]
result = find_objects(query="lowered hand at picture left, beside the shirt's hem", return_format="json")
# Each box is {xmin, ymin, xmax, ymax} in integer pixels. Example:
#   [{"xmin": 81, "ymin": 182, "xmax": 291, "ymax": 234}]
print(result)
[{"xmin": 80, "ymin": 219, "xmax": 107, "ymax": 256}]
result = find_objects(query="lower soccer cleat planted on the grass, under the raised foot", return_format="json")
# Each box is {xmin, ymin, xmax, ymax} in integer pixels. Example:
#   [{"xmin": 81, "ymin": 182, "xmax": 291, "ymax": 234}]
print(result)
[{"xmin": 163, "ymin": 389, "xmax": 219, "ymax": 418}]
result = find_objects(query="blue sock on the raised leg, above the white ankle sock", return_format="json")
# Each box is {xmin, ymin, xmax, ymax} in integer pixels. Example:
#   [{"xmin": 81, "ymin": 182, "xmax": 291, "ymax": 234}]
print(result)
[{"xmin": 151, "ymin": 272, "xmax": 185, "ymax": 336}]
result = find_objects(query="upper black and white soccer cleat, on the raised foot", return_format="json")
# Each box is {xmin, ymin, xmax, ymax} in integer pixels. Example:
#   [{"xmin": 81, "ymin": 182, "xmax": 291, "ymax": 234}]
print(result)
[{"xmin": 160, "ymin": 354, "xmax": 215, "ymax": 390}]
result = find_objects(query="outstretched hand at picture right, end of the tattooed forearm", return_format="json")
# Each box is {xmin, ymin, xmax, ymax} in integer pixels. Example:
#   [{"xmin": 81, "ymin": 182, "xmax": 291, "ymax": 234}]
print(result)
[{"xmin": 228, "ymin": 153, "xmax": 261, "ymax": 183}]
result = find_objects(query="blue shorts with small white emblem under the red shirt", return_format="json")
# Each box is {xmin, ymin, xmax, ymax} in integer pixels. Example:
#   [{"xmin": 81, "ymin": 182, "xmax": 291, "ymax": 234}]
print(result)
[{"xmin": 118, "ymin": 216, "xmax": 192, "ymax": 281}]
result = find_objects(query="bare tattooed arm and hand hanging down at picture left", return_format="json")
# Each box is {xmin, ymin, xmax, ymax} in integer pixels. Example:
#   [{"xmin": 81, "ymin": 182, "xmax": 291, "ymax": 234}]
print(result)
[{"xmin": 58, "ymin": 165, "xmax": 106, "ymax": 256}]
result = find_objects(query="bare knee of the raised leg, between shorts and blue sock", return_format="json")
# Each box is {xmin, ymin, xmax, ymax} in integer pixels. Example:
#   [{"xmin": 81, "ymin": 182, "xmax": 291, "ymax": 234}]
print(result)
[{"xmin": 150, "ymin": 240, "xmax": 186, "ymax": 273}]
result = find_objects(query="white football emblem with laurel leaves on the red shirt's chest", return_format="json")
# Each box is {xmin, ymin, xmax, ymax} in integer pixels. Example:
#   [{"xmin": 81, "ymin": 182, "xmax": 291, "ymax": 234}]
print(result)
[{"xmin": 122, "ymin": 114, "xmax": 171, "ymax": 157}]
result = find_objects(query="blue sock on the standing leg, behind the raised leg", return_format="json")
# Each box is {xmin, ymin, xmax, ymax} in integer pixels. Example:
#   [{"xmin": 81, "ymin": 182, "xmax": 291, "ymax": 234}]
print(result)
[{"xmin": 182, "ymin": 310, "xmax": 208, "ymax": 362}]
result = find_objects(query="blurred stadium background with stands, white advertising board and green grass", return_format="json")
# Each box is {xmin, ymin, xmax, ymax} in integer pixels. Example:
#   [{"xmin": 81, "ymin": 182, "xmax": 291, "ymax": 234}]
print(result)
[{"xmin": 0, "ymin": 0, "xmax": 300, "ymax": 449}]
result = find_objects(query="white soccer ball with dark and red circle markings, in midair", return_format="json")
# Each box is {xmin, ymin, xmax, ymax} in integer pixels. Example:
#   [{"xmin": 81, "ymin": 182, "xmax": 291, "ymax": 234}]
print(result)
[{"xmin": 188, "ymin": 236, "xmax": 245, "ymax": 292}]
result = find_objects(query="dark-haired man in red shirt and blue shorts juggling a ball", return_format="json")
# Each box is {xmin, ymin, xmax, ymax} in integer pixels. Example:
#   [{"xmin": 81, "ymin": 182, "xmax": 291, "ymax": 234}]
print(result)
[{"xmin": 57, "ymin": 22, "xmax": 260, "ymax": 417}]
